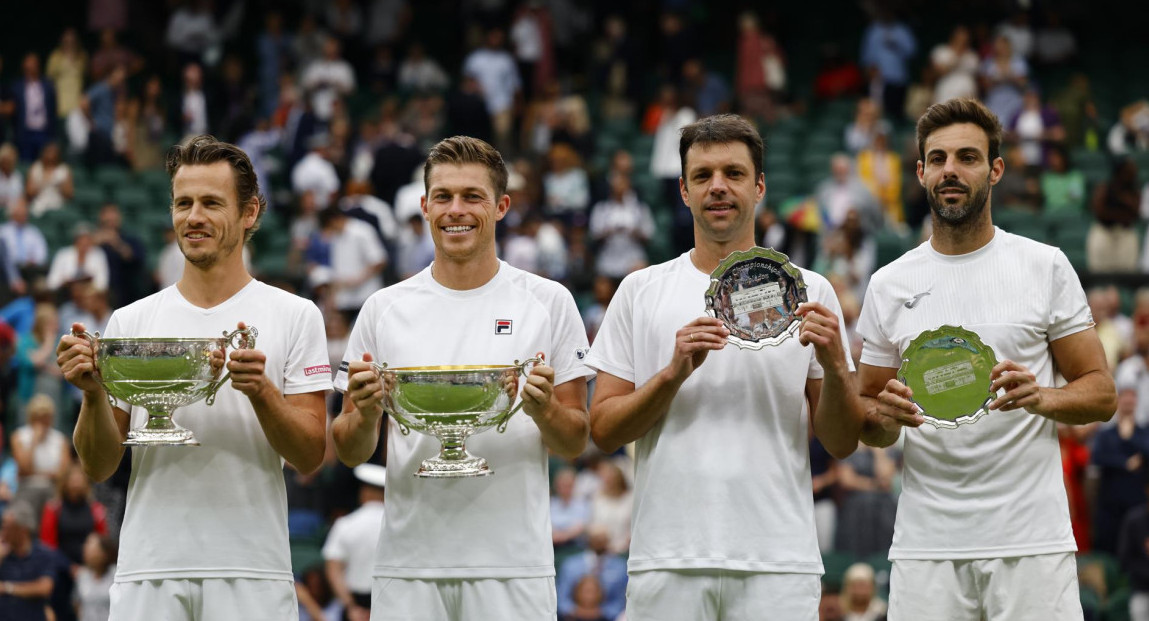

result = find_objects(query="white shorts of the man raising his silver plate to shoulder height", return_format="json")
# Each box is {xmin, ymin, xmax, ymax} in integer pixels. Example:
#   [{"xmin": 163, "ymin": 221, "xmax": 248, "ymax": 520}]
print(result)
[{"xmin": 626, "ymin": 569, "xmax": 822, "ymax": 621}]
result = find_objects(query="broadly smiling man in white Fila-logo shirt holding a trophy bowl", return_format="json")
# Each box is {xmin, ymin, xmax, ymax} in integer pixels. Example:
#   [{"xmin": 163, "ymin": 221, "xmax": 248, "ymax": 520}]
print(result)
[{"xmin": 332, "ymin": 137, "xmax": 591, "ymax": 621}]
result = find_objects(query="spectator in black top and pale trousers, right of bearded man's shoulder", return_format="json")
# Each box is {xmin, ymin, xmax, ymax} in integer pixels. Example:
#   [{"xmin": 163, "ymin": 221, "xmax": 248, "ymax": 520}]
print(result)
[{"xmin": 1086, "ymin": 158, "xmax": 1141, "ymax": 273}]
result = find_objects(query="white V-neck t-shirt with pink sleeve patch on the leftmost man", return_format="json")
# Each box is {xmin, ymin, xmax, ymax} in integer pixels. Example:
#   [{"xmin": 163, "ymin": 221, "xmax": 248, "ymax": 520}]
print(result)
[{"xmin": 105, "ymin": 281, "xmax": 331, "ymax": 582}]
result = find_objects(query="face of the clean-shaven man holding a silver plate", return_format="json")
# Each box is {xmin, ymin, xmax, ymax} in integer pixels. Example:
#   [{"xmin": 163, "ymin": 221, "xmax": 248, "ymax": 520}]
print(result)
[{"xmin": 679, "ymin": 143, "xmax": 766, "ymax": 244}]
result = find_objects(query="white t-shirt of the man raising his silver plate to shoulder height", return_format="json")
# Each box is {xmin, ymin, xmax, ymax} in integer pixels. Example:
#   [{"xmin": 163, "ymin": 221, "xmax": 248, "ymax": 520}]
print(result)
[{"xmin": 587, "ymin": 252, "xmax": 849, "ymax": 574}]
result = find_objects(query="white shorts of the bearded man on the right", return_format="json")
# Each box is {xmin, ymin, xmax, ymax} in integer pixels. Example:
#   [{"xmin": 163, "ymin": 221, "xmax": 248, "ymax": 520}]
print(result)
[{"xmin": 888, "ymin": 552, "xmax": 1084, "ymax": 621}]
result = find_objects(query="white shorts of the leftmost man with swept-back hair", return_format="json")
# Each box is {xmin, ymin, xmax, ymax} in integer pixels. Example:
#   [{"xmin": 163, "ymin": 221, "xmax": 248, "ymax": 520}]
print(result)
[{"xmin": 108, "ymin": 578, "xmax": 299, "ymax": 621}]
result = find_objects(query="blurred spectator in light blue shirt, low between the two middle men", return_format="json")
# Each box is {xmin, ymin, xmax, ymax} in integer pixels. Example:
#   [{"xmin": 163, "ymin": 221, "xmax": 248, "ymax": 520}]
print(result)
[{"xmin": 555, "ymin": 524, "xmax": 626, "ymax": 620}]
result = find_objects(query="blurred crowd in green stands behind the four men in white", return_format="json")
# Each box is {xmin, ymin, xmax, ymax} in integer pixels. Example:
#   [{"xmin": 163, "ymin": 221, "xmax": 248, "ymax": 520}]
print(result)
[{"xmin": 0, "ymin": 0, "xmax": 1149, "ymax": 620}]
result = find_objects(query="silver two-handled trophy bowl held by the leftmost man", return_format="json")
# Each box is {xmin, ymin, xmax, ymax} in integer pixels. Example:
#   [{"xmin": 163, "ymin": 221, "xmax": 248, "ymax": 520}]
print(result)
[{"xmin": 82, "ymin": 327, "xmax": 259, "ymax": 446}]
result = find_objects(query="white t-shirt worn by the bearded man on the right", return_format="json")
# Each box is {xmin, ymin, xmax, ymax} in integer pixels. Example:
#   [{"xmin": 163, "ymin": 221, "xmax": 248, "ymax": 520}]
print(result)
[{"xmin": 857, "ymin": 229, "xmax": 1093, "ymax": 560}]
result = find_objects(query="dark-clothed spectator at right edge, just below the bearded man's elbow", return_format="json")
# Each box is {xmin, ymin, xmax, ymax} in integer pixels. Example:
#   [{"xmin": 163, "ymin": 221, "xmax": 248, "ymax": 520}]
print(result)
[{"xmin": 1090, "ymin": 383, "xmax": 1149, "ymax": 554}]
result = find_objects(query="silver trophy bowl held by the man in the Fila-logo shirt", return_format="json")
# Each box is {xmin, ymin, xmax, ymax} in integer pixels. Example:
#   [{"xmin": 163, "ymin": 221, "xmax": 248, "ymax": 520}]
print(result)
[{"xmin": 371, "ymin": 358, "xmax": 542, "ymax": 478}]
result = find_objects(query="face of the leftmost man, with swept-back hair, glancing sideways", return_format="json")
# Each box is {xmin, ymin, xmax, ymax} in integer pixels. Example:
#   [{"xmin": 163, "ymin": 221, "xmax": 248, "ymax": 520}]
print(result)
[{"xmin": 171, "ymin": 161, "xmax": 259, "ymax": 269}]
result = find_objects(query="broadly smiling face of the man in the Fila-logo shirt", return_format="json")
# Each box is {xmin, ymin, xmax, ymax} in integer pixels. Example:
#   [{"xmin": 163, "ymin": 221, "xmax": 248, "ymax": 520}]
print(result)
[{"xmin": 422, "ymin": 163, "xmax": 510, "ymax": 263}]
